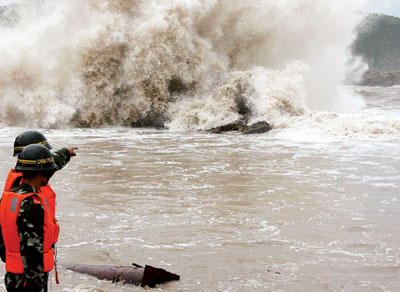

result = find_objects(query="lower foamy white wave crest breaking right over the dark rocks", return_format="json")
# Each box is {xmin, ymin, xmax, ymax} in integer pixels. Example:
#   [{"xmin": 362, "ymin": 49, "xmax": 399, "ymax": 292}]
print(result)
[{"xmin": 167, "ymin": 62, "xmax": 308, "ymax": 130}]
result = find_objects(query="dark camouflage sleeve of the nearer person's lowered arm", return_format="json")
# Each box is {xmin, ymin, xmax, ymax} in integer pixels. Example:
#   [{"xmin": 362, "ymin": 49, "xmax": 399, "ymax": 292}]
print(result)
[{"xmin": 17, "ymin": 197, "xmax": 45, "ymax": 292}]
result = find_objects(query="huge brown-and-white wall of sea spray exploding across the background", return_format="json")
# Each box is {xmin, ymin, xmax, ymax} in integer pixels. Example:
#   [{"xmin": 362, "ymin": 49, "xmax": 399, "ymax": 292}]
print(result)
[{"xmin": 0, "ymin": 0, "xmax": 368, "ymax": 130}]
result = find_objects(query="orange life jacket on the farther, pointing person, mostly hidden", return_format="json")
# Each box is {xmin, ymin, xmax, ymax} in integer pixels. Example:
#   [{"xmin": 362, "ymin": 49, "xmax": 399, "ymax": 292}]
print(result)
[{"xmin": 4, "ymin": 169, "xmax": 60, "ymax": 242}]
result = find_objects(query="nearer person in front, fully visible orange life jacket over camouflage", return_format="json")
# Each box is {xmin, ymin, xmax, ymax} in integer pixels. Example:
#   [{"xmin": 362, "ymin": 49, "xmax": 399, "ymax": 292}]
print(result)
[{"xmin": 0, "ymin": 144, "xmax": 58, "ymax": 292}]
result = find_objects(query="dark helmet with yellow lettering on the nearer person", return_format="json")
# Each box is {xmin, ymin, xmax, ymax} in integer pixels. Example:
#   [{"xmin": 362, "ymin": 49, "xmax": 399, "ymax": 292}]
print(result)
[{"xmin": 15, "ymin": 144, "xmax": 57, "ymax": 172}]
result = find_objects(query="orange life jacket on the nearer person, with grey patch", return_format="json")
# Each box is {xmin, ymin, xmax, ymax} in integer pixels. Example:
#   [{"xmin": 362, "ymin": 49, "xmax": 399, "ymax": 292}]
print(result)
[{"xmin": 0, "ymin": 192, "xmax": 58, "ymax": 274}]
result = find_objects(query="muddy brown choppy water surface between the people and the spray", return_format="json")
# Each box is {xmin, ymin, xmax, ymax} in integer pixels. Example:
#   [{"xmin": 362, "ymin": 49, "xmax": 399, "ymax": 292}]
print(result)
[{"xmin": 0, "ymin": 90, "xmax": 400, "ymax": 292}]
